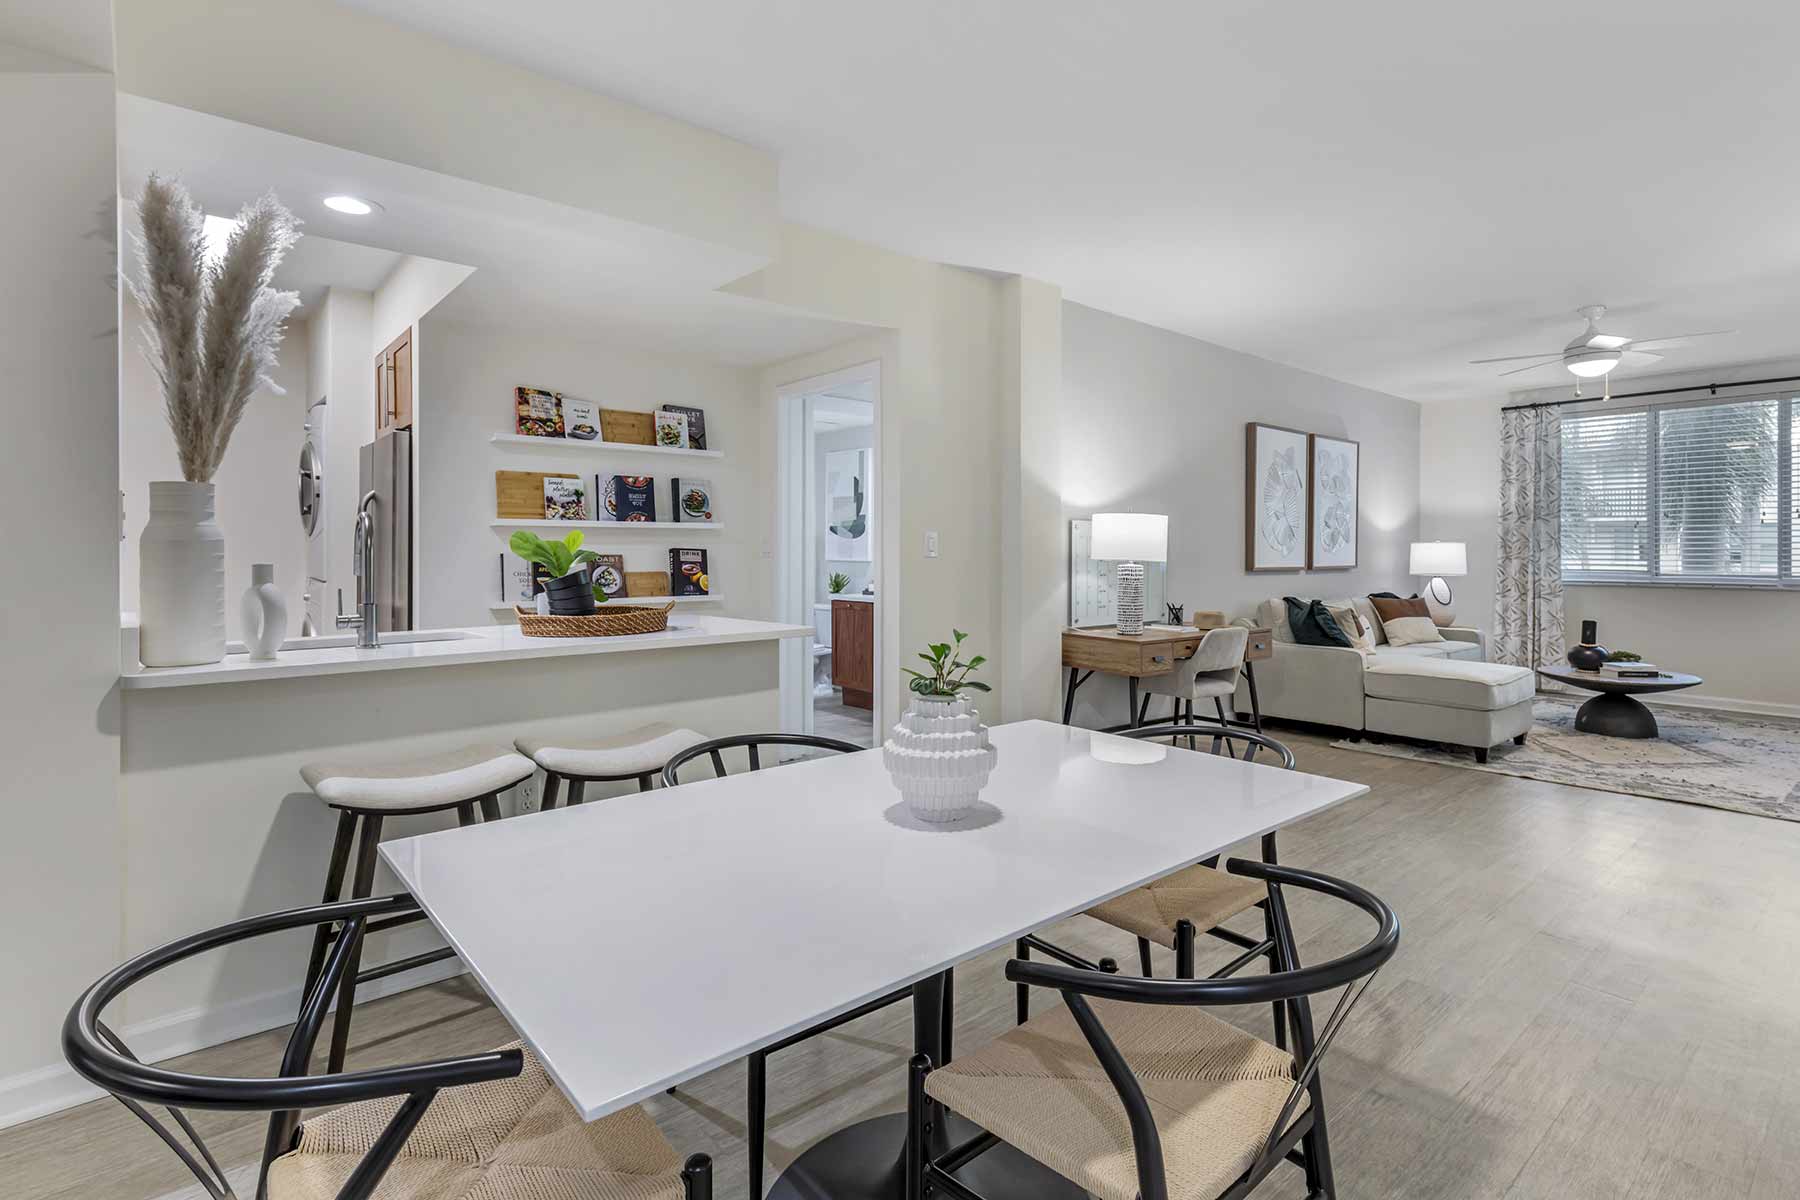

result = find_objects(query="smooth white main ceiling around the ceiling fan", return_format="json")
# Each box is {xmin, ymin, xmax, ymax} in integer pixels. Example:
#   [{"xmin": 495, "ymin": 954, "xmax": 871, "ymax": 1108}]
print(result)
[{"xmin": 349, "ymin": 0, "xmax": 1800, "ymax": 399}]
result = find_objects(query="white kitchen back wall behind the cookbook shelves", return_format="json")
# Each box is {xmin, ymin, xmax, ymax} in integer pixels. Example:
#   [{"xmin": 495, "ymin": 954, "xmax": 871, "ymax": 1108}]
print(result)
[{"xmin": 416, "ymin": 317, "xmax": 774, "ymax": 628}]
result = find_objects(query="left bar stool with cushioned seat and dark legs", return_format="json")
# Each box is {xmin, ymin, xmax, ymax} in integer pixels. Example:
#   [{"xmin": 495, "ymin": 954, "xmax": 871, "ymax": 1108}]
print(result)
[{"xmin": 301, "ymin": 745, "xmax": 531, "ymax": 1074}]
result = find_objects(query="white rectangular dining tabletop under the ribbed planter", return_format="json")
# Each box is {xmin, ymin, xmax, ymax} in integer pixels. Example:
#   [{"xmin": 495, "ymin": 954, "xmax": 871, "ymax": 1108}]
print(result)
[{"xmin": 382, "ymin": 720, "xmax": 1368, "ymax": 1194}]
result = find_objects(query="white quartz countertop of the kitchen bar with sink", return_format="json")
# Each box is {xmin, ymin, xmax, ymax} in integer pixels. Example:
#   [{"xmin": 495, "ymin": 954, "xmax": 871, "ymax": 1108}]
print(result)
[{"xmin": 119, "ymin": 615, "xmax": 814, "ymax": 689}]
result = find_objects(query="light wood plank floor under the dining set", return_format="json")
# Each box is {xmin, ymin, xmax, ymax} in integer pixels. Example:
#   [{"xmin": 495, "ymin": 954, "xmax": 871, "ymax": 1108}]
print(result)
[{"xmin": 0, "ymin": 734, "xmax": 1800, "ymax": 1200}]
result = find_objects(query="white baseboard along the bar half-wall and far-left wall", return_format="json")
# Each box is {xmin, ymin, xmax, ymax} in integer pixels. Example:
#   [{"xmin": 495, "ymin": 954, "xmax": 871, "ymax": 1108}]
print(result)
[{"xmin": 0, "ymin": 959, "xmax": 464, "ymax": 1130}]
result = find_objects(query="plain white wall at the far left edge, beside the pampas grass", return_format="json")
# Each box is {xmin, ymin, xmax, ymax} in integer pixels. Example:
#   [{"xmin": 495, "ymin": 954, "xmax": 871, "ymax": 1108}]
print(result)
[{"xmin": 0, "ymin": 28, "xmax": 124, "ymax": 1121}]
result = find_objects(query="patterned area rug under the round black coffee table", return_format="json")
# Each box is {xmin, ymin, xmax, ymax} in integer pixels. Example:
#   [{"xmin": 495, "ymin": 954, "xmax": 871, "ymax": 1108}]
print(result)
[{"xmin": 1332, "ymin": 696, "xmax": 1800, "ymax": 820}]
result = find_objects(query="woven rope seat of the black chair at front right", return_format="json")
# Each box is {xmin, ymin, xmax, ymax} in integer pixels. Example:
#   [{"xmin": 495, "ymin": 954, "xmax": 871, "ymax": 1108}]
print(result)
[{"xmin": 925, "ymin": 1000, "xmax": 1305, "ymax": 1200}]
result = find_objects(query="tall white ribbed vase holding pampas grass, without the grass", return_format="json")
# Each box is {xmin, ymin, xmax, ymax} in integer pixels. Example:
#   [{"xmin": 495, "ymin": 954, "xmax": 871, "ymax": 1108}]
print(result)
[{"xmin": 137, "ymin": 480, "xmax": 225, "ymax": 667}]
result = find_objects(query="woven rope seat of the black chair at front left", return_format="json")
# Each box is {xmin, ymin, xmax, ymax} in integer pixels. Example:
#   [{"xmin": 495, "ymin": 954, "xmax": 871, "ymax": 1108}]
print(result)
[{"xmin": 268, "ymin": 1042, "xmax": 684, "ymax": 1200}]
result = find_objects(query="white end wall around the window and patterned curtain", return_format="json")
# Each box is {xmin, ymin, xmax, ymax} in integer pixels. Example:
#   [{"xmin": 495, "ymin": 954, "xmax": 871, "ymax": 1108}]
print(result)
[{"xmin": 1418, "ymin": 360, "xmax": 1800, "ymax": 716}]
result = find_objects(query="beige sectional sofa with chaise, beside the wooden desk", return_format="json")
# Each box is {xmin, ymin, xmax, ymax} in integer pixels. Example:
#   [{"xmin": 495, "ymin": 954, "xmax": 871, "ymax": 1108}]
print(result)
[{"xmin": 1237, "ymin": 597, "xmax": 1537, "ymax": 763}]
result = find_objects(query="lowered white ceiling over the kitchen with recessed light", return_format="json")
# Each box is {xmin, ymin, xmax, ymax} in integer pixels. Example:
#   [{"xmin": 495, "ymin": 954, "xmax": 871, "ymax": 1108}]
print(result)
[{"xmin": 119, "ymin": 95, "xmax": 864, "ymax": 365}]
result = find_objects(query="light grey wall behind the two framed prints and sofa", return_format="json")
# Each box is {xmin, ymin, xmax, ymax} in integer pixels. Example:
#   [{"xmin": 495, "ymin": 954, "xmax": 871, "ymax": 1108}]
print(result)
[{"xmin": 1060, "ymin": 302, "xmax": 1418, "ymax": 725}]
